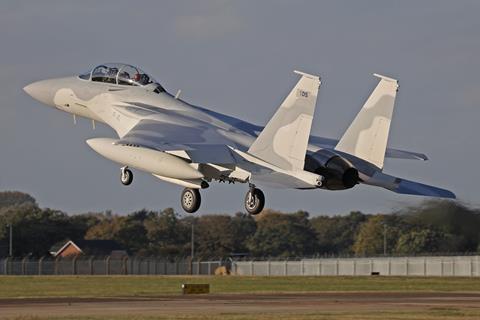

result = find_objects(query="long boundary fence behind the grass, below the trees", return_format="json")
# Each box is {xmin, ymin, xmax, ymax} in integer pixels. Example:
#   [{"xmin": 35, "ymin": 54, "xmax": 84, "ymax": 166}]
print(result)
[{"xmin": 0, "ymin": 256, "xmax": 480, "ymax": 277}]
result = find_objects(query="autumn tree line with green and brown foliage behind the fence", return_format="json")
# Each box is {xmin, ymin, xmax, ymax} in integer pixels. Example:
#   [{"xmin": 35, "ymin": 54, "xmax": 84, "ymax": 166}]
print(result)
[{"xmin": 0, "ymin": 191, "xmax": 480, "ymax": 259}]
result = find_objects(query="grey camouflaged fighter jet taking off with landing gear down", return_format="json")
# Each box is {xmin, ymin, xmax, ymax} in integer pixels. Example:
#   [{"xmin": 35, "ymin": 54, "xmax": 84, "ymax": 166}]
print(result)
[{"xmin": 24, "ymin": 63, "xmax": 455, "ymax": 214}]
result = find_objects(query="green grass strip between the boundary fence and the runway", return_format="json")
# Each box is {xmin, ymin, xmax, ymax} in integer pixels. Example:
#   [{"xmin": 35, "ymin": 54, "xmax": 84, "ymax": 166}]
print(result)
[{"xmin": 0, "ymin": 276, "xmax": 480, "ymax": 298}]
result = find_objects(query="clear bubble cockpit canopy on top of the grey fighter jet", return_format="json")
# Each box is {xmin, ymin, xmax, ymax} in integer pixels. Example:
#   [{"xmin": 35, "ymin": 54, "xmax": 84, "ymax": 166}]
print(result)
[{"xmin": 79, "ymin": 63, "xmax": 165, "ymax": 93}]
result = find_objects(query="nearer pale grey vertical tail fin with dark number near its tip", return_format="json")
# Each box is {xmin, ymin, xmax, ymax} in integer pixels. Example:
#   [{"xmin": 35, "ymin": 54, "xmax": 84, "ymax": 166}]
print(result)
[{"xmin": 248, "ymin": 71, "xmax": 320, "ymax": 171}]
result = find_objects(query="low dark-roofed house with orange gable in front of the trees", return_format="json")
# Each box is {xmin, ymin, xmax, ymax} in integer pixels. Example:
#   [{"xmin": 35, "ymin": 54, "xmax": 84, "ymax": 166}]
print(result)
[{"xmin": 49, "ymin": 240, "xmax": 127, "ymax": 257}]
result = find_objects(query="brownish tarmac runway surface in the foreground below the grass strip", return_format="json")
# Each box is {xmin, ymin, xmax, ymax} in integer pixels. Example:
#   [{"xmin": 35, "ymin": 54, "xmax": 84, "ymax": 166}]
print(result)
[{"xmin": 0, "ymin": 292, "xmax": 480, "ymax": 319}]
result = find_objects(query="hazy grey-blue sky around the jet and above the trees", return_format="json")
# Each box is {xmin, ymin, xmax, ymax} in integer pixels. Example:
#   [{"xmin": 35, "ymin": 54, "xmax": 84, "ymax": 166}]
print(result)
[{"xmin": 0, "ymin": 0, "xmax": 480, "ymax": 216}]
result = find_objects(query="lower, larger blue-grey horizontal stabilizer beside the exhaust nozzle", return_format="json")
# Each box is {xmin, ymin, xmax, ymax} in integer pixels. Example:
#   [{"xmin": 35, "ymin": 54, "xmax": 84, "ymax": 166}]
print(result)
[{"xmin": 363, "ymin": 172, "xmax": 456, "ymax": 199}]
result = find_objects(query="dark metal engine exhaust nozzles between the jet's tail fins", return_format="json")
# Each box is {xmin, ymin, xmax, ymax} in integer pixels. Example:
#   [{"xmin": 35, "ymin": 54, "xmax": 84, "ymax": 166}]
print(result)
[{"xmin": 305, "ymin": 149, "xmax": 359, "ymax": 190}]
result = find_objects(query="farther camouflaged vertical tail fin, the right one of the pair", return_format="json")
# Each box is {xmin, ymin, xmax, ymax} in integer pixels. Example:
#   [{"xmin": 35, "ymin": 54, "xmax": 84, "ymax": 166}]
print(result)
[{"xmin": 335, "ymin": 74, "xmax": 398, "ymax": 169}]
